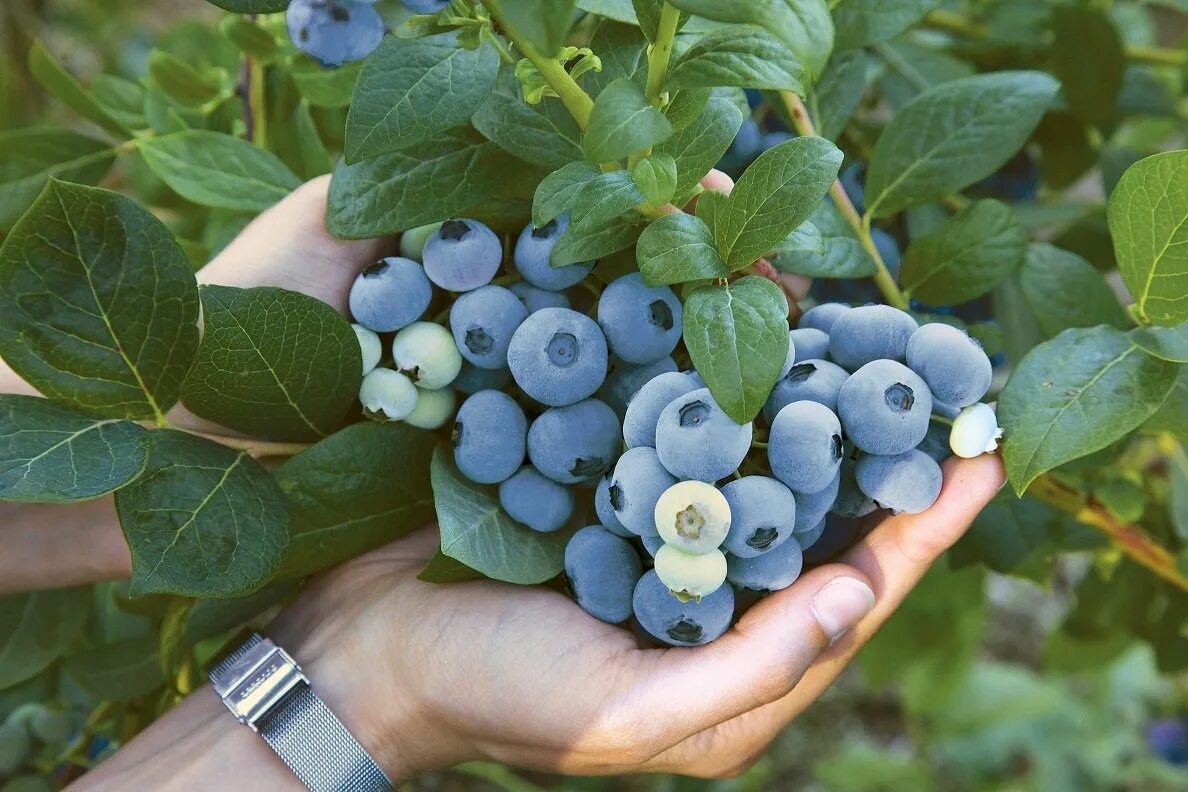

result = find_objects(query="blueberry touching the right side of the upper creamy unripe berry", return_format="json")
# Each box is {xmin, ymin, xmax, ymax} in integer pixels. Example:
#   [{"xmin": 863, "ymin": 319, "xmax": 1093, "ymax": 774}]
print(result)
[{"xmin": 722, "ymin": 476, "xmax": 797, "ymax": 558}]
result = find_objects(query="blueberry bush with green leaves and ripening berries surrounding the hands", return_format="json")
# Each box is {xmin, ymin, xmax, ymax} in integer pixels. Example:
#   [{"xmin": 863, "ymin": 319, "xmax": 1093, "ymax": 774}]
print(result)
[{"xmin": 0, "ymin": 0, "xmax": 1188, "ymax": 792}]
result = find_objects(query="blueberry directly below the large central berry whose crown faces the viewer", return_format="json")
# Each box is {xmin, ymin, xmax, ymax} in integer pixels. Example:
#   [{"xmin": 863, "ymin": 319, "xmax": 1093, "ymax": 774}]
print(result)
[{"xmin": 527, "ymin": 399, "xmax": 620, "ymax": 484}]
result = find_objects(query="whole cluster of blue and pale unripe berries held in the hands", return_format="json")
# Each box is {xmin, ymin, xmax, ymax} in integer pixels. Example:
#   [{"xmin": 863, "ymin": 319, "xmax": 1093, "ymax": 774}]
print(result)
[{"xmin": 350, "ymin": 207, "xmax": 997, "ymax": 646}]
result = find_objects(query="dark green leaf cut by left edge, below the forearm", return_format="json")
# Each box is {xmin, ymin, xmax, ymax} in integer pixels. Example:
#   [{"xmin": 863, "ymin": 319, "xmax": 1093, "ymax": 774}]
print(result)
[{"xmin": 0, "ymin": 587, "xmax": 90, "ymax": 690}]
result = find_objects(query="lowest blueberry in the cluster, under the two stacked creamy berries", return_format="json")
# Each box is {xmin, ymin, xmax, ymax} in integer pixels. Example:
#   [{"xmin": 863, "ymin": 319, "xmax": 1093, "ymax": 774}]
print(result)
[{"xmin": 632, "ymin": 570, "xmax": 734, "ymax": 646}]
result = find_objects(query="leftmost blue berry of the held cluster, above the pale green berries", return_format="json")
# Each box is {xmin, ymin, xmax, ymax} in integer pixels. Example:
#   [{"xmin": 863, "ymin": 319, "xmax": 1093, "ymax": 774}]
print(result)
[{"xmin": 348, "ymin": 256, "xmax": 434, "ymax": 332}]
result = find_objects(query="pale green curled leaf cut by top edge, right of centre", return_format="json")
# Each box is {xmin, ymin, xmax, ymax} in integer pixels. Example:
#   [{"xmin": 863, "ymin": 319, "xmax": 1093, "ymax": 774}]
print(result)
[{"xmin": 671, "ymin": 0, "xmax": 833, "ymax": 75}]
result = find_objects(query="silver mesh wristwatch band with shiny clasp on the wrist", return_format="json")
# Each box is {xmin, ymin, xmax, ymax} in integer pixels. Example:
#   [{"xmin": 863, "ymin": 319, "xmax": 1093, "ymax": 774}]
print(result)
[{"xmin": 209, "ymin": 633, "xmax": 393, "ymax": 792}]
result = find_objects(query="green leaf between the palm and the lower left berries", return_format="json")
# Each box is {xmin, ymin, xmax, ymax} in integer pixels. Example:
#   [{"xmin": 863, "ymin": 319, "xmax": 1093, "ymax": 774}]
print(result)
[{"xmin": 431, "ymin": 445, "xmax": 569, "ymax": 585}]
